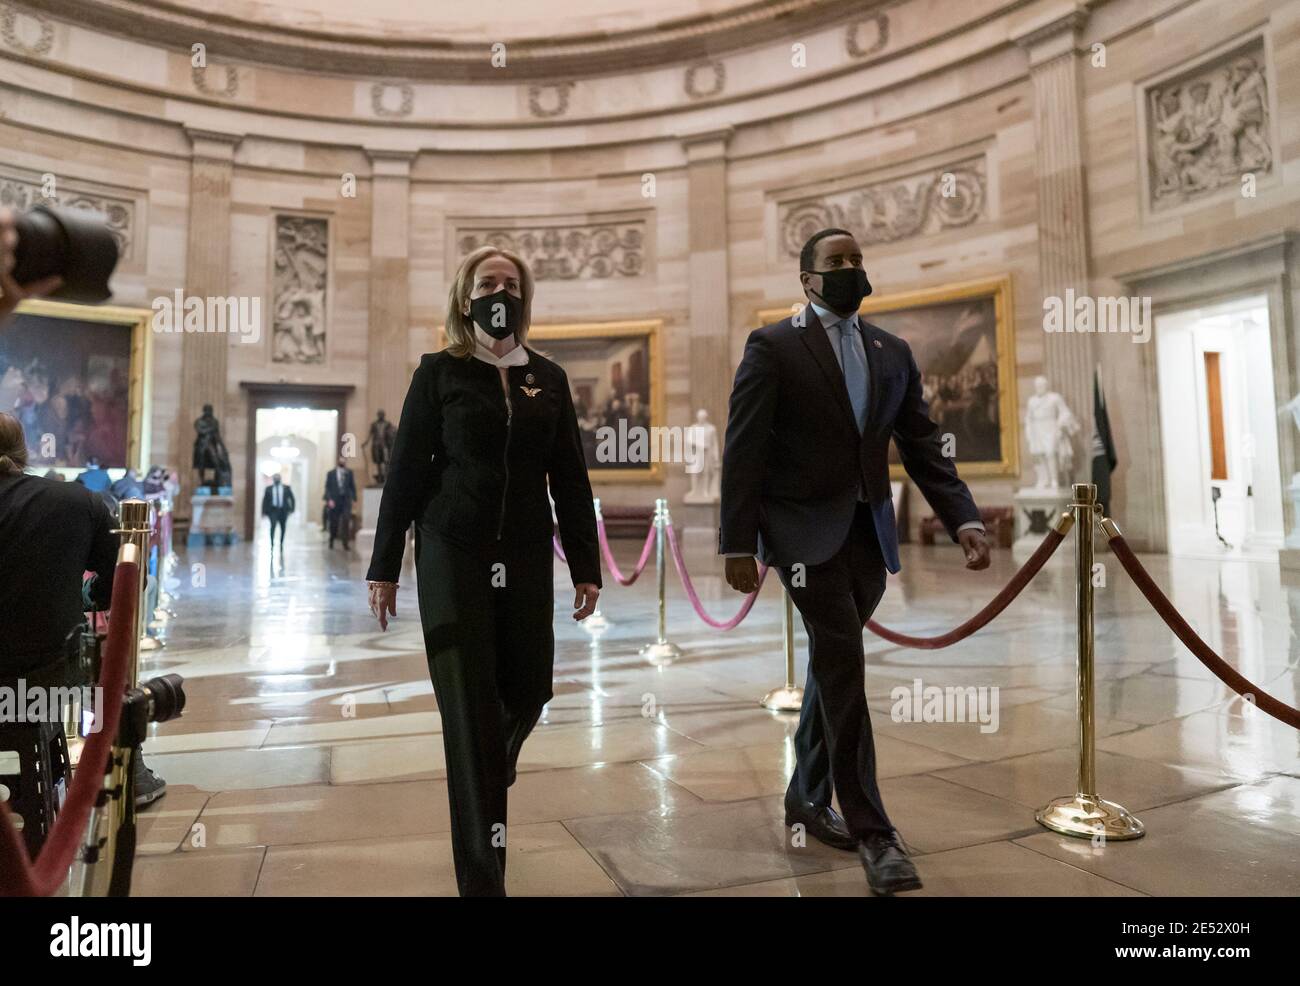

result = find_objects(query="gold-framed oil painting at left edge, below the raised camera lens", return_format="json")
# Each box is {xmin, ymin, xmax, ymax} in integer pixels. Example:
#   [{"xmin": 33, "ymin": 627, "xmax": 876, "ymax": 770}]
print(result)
[{"xmin": 0, "ymin": 300, "xmax": 152, "ymax": 471}]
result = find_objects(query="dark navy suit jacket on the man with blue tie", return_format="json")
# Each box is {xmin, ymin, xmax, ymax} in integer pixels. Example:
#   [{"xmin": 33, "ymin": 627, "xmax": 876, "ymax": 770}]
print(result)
[{"xmin": 718, "ymin": 306, "xmax": 979, "ymax": 572}]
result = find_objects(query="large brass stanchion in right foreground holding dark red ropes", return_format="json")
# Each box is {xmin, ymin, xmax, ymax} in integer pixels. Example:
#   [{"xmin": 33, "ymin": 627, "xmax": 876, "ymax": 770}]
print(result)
[{"xmin": 1034, "ymin": 483, "xmax": 1147, "ymax": 840}]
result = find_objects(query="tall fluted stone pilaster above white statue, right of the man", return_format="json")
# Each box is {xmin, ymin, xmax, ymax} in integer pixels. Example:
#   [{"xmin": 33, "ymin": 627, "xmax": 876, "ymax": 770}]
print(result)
[{"xmin": 1015, "ymin": 8, "xmax": 1097, "ymax": 480}]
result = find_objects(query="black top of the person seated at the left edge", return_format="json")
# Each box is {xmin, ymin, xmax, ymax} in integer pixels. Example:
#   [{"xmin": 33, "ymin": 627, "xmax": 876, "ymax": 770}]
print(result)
[{"xmin": 0, "ymin": 473, "xmax": 117, "ymax": 678}]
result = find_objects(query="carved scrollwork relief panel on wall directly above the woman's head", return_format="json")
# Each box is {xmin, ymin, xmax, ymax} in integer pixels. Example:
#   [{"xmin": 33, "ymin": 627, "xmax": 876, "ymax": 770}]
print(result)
[{"xmin": 456, "ymin": 220, "xmax": 645, "ymax": 281}]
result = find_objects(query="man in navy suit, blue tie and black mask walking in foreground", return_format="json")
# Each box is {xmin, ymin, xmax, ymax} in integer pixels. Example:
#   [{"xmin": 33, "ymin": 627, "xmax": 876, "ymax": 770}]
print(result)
[{"xmin": 718, "ymin": 229, "xmax": 988, "ymax": 894}]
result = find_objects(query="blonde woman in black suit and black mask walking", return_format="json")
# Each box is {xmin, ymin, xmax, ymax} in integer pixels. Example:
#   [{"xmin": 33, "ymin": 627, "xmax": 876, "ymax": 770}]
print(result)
[{"xmin": 367, "ymin": 247, "xmax": 601, "ymax": 896}]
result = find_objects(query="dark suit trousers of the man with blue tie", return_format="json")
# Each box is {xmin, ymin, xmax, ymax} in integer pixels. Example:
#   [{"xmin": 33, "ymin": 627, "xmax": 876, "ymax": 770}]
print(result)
[{"xmin": 779, "ymin": 503, "xmax": 893, "ymax": 839}]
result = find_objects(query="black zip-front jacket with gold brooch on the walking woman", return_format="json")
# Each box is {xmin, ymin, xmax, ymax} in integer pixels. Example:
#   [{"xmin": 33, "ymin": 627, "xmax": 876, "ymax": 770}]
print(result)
[{"xmin": 367, "ymin": 350, "xmax": 601, "ymax": 585}]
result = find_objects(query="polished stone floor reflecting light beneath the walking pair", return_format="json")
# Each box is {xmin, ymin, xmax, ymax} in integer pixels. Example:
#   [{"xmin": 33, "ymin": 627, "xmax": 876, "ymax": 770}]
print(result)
[{"xmin": 135, "ymin": 520, "xmax": 1300, "ymax": 896}]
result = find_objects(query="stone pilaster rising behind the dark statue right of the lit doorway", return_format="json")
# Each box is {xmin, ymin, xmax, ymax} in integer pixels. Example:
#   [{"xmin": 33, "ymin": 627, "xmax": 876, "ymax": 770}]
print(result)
[{"xmin": 360, "ymin": 150, "xmax": 415, "ymax": 440}]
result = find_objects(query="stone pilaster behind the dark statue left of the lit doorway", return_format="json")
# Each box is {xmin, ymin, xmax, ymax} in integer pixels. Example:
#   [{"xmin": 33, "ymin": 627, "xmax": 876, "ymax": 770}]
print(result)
[{"xmin": 178, "ymin": 129, "xmax": 242, "ymax": 502}]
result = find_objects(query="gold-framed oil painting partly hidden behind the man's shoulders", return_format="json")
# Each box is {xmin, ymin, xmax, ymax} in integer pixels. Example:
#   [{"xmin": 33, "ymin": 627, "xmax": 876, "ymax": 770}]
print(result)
[{"xmin": 758, "ymin": 276, "xmax": 1019, "ymax": 479}]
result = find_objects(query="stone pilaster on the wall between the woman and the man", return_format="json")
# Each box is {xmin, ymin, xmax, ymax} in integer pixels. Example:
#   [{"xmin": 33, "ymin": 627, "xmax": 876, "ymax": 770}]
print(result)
[{"xmin": 681, "ymin": 127, "xmax": 731, "ymax": 437}]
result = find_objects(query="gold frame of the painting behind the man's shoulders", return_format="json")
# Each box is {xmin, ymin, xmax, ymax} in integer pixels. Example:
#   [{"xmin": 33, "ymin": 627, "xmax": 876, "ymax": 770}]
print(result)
[{"xmin": 755, "ymin": 274, "xmax": 1021, "ymax": 480}]
